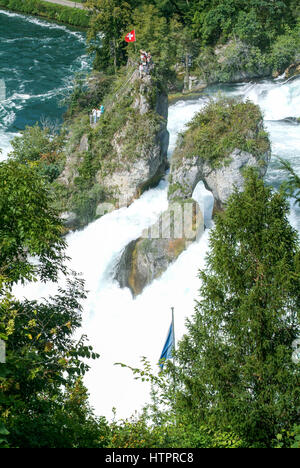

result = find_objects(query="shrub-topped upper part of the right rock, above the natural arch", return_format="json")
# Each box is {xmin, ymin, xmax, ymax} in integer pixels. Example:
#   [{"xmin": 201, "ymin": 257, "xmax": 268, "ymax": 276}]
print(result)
[{"xmin": 169, "ymin": 100, "xmax": 271, "ymax": 211}]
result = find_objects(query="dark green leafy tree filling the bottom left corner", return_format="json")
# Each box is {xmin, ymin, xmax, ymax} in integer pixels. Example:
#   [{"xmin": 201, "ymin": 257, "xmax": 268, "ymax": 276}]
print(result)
[{"xmin": 0, "ymin": 279, "xmax": 106, "ymax": 448}]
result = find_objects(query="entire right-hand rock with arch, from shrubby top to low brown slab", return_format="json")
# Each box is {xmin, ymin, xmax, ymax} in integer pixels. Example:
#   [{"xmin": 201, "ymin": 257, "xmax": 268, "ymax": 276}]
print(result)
[{"xmin": 115, "ymin": 99, "xmax": 271, "ymax": 296}]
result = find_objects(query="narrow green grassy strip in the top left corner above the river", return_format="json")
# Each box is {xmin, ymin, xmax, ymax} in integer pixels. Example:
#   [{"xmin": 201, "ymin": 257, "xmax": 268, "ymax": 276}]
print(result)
[{"xmin": 0, "ymin": 0, "xmax": 89, "ymax": 28}]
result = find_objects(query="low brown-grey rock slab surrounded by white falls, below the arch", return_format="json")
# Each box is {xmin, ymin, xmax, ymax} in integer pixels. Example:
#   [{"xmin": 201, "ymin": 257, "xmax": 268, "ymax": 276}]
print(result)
[{"xmin": 115, "ymin": 200, "xmax": 204, "ymax": 296}]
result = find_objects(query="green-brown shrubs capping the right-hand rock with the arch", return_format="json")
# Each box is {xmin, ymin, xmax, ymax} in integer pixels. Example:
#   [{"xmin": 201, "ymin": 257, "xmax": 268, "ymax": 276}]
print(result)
[{"xmin": 174, "ymin": 97, "xmax": 270, "ymax": 167}]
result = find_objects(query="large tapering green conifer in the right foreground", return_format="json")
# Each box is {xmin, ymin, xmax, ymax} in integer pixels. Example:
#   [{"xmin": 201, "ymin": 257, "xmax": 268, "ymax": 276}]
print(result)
[{"xmin": 176, "ymin": 171, "xmax": 300, "ymax": 446}]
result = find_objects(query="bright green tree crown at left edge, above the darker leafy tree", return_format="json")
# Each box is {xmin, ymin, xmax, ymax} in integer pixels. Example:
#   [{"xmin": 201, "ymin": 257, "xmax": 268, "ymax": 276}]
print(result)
[{"xmin": 0, "ymin": 161, "xmax": 65, "ymax": 283}]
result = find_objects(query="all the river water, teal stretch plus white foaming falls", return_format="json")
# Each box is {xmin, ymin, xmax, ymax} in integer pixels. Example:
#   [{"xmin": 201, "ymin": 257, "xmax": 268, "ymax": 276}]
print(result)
[{"xmin": 0, "ymin": 12, "xmax": 300, "ymax": 418}]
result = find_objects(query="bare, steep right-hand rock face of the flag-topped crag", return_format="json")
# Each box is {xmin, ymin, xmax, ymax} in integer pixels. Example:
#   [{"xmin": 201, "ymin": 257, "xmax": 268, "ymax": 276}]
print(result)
[{"xmin": 96, "ymin": 72, "xmax": 169, "ymax": 205}]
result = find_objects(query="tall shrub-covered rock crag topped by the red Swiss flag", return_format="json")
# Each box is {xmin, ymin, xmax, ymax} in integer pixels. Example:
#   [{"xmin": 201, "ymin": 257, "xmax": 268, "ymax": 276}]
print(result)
[{"xmin": 57, "ymin": 69, "xmax": 169, "ymax": 227}]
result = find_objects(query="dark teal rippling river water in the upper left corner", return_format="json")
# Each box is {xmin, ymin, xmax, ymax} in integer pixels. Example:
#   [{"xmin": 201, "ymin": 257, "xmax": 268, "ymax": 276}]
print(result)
[{"xmin": 0, "ymin": 10, "xmax": 89, "ymax": 158}]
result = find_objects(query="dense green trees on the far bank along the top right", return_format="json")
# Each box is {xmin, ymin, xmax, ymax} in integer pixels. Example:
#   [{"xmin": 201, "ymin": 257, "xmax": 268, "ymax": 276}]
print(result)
[{"xmin": 87, "ymin": 0, "xmax": 300, "ymax": 87}]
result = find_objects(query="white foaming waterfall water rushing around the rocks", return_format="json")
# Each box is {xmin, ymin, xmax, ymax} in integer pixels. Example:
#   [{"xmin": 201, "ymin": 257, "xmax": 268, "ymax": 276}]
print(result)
[{"xmin": 12, "ymin": 80, "xmax": 300, "ymax": 418}]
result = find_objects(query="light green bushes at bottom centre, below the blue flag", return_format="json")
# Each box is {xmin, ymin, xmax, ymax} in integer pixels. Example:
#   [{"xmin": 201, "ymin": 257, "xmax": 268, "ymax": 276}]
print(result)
[{"xmin": 113, "ymin": 358, "xmax": 245, "ymax": 448}]
